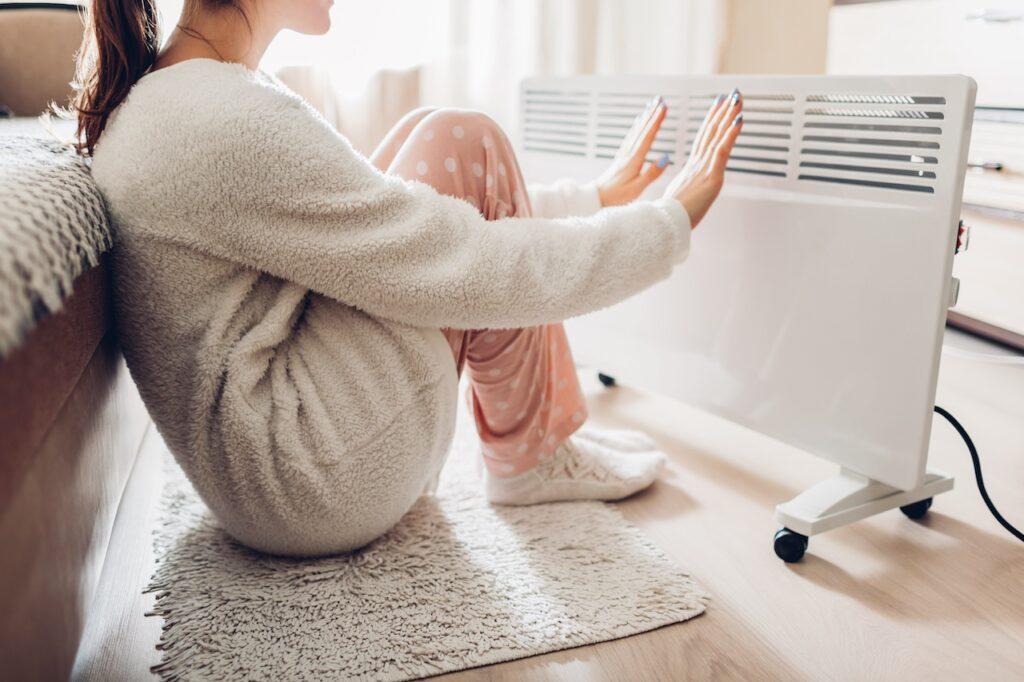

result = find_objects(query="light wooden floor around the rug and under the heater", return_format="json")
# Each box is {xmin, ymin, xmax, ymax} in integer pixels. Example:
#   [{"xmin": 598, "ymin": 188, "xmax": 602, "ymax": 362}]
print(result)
[{"xmin": 75, "ymin": 327, "xmax": 1024, "ymax": 682}]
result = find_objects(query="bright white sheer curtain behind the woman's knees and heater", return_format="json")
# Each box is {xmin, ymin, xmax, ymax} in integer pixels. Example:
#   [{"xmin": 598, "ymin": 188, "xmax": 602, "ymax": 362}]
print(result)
[{"xmin": 160, "ymin": 0, "xmax": 728, "ymax": 153}]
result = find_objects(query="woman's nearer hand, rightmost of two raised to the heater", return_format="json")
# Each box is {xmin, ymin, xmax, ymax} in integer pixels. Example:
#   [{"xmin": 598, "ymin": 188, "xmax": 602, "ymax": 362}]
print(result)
[{"xmin": 665, "ymin": 90, "xmax": 743, "ymax": 227}]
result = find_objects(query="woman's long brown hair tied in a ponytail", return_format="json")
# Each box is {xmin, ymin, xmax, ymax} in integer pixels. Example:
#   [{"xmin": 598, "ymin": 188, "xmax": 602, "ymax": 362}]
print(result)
[{"xmin": 72, "ymin": 0, "xmax": 246, "ymax": 155}]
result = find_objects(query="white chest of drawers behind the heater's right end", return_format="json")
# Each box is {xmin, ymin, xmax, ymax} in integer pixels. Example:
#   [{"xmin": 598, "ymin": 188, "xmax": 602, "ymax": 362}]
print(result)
[{"xmin": 828, "ymin": 0, "xmax": 1024, "ymax": 349}]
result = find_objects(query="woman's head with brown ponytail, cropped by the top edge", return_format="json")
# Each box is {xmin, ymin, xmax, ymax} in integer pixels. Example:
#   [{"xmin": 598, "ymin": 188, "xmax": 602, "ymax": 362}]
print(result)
[{"xmin": 74, "ymin": 0, "xmax": 334, "ymax": 154}]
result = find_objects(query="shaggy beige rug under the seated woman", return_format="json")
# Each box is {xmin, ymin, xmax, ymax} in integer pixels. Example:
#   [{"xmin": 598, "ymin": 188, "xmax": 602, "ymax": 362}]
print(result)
[{"xmin": 150, "ymin": 416, "xmax": 707, "ymax": 680}]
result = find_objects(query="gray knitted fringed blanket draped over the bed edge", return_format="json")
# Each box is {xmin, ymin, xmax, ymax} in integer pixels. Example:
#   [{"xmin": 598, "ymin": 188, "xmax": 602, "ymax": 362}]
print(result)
[{"xmin": 0, "ymin": 135, "xmax": 111, "ymax": 357}]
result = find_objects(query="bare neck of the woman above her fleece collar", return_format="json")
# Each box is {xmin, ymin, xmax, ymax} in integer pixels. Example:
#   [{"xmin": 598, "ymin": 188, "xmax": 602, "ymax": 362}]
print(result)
[{"xmin": 154, "ymin": 8, "xmax": 280, "ymax": 71}]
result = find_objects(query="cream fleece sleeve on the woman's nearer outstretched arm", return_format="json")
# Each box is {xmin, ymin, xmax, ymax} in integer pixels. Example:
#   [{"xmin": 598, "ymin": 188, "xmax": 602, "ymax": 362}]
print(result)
[{"xmin": 165, "ymin": 84, "xmax": 690, "ymax": 329}]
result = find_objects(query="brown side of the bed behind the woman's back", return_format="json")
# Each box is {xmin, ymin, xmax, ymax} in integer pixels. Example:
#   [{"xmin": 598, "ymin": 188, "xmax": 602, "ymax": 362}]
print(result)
[{"xmin": 0, "ymin": 118, "xmax": 157, "ymax": 680}]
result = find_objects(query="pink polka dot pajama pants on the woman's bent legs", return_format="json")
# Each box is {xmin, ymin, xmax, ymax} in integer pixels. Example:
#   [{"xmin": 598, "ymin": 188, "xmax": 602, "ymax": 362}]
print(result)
[{"xmin": 371, "ymin": 109, "xmax": 587, "ymax": 476}]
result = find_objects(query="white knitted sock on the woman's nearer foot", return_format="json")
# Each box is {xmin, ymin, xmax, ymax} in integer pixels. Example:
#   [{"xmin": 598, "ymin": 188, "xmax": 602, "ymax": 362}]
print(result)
[{"xmin": 484, "ymin": 435, "xmax": 666, "ymax": 505}]
